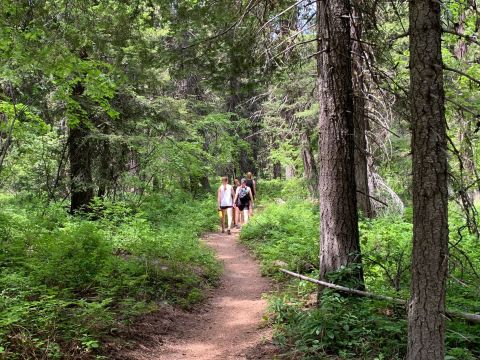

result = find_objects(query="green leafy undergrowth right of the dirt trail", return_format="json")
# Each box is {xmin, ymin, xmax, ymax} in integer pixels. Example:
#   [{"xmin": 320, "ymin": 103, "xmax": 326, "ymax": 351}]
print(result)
[{"xmin": 241, "ymin": 181, "xmax": 480, "ymax": 360}]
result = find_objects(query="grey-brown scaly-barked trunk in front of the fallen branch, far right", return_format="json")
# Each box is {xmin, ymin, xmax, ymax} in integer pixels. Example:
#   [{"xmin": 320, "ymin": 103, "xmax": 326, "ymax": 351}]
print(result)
[{"xmin": 408, "ymin": 0, "xmax": 448, "ymax": 360}]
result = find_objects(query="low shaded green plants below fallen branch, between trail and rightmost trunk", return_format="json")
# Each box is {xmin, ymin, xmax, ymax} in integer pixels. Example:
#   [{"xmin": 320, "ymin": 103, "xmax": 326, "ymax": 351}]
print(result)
[{"xmin": 270, "ymin": 290, "xmax": 407, "ymax": 360}]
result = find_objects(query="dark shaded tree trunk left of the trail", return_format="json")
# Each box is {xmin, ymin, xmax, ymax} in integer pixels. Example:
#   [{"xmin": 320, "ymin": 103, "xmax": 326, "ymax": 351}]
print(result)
[{"xmin": 68, "ymin": 83, "xmax": 93, "ymax": 213}]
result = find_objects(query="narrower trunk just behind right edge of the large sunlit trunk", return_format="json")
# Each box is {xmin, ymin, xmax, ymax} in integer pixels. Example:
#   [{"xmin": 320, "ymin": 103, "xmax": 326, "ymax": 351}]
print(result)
[{"xmin": 351, "ymin": 9, "xmax": 373, "ymax": 218}]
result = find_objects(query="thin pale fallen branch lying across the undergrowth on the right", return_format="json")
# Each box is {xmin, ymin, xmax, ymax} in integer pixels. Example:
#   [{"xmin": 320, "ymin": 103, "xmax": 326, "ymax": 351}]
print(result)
[{"xmin": 279, "ymin": 269, "xmax": 480, "ymax": 324}]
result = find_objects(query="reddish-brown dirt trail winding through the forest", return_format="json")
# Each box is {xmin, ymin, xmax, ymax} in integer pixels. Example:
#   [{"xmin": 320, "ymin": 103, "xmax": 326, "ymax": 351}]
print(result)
[{"xmin": 124, "ymin": 231, "xmax": 275, "ymax": 360}]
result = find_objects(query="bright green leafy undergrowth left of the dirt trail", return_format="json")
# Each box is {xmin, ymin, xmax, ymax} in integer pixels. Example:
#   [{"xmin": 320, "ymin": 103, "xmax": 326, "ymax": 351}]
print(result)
[{"xmin": 0, "ymin": 196, "xmax": 220, "ymax": 359}]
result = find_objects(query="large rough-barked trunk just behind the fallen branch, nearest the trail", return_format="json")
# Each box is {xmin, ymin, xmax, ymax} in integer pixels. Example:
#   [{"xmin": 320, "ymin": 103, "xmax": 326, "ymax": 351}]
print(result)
[{"xmin": 317, "ymin": 0, "xmax": 363, "ymax": 287}]
